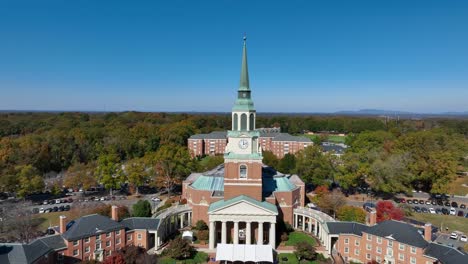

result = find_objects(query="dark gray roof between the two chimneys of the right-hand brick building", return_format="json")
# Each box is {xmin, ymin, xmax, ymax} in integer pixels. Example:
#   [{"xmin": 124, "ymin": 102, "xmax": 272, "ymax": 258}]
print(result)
[{"xmin": 364, "ymin": 220, "xmax": 428, "ymax": 248}]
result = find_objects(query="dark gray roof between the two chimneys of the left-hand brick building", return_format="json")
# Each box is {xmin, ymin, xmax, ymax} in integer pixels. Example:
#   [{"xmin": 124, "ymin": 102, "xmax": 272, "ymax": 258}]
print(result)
[{"xmin": 63, "ymin": 214, "xmax": 125, "ymax": 241}]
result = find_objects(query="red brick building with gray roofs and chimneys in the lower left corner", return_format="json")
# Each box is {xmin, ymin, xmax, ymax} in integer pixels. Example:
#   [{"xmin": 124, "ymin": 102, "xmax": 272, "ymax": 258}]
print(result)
[{"xmin": 0, "ymin": 206, "xmax": 159, "ymax": 264}]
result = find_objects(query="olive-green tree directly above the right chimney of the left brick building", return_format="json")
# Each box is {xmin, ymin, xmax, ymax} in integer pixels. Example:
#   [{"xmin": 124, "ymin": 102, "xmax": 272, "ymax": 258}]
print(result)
[{"xmin": 96, "ymin": 154, "xmax": 124, "ymax": 195}]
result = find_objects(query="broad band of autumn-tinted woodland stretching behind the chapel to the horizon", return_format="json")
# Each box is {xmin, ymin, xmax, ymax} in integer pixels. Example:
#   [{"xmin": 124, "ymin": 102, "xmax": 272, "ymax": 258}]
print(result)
[{"xmin": 0, "ymin": 112, "xmax": 468, "ymax": 196}]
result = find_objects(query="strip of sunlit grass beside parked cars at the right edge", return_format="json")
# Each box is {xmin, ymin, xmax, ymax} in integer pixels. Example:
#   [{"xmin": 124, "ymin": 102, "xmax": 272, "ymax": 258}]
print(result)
[{"xmin": 409, "ymin": 213, "xmax": 468, "ymax": 234}]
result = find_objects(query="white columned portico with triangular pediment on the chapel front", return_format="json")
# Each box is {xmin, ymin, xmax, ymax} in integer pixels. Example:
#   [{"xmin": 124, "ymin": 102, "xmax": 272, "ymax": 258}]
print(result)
[{"xmin": 208, "ymin": 195, "xmax": 278, "ymax": 249}]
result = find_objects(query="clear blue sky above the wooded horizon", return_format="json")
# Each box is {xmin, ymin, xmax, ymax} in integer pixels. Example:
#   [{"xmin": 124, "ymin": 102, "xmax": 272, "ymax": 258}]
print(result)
[{"xmin": 0, "ymin": 0, "xmax": 468, "ymax": 112}]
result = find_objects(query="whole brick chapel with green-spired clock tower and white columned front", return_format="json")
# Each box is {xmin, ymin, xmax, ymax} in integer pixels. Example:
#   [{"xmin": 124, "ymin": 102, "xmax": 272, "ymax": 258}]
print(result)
[{"xmin": 182, "ymin": 37, "xmax": 305, "ymax": 249}]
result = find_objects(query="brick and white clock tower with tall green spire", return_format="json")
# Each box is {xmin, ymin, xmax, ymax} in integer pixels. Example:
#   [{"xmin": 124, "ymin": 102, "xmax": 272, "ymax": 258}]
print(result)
[{"xmin": 224, "ymin": 36, "xmax": 263, "ymax": 201}]
